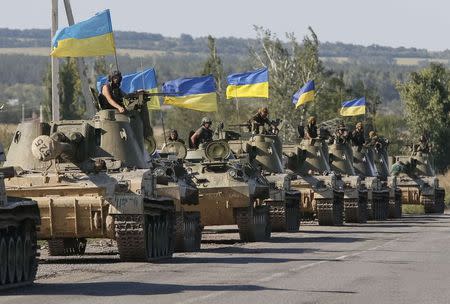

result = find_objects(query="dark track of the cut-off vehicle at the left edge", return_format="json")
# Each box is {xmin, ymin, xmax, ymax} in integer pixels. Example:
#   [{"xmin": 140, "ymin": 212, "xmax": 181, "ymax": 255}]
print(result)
[{"xmin": 0, "ymin": 221, "xmax": 38, "ymax": 290}]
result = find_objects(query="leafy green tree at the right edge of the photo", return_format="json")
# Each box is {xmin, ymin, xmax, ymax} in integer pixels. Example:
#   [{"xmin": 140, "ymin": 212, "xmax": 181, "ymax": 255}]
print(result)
[{"xmin": 397, "ymin": 63, "xmax": 450, "ymax": 171}]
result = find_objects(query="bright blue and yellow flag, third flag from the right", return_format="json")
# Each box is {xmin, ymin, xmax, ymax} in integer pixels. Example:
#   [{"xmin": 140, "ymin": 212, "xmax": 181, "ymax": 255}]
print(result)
[{"xmin": 227, "ymin": 68, "xmax": 269, "ymax": 99}]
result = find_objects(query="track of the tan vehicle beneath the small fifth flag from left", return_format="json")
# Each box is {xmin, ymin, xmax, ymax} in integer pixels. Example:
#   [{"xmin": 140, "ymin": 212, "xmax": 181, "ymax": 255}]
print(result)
[{"xmin": 316, "ymin": 199, "xmax": 344, "ymax": 226}]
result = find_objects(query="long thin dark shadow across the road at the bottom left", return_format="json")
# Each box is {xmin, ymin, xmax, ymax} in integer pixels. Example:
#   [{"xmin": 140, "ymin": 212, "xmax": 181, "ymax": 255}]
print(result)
[{"xmin": 2, "ymin": 282, "xmax": 288, "ymax": 297}]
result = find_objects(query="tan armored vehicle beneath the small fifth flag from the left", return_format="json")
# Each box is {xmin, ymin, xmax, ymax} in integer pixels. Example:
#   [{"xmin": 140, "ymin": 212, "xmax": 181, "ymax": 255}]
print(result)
[{"xmin": 283, "ymin": 137, "xmax": 344, "ymax": 226}]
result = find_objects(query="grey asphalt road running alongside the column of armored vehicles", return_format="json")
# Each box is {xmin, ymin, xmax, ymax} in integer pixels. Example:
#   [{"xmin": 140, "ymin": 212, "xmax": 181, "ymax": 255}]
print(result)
[{"xmin": 0, "ymin": 214, "xmax": 450, "ymax": 304}]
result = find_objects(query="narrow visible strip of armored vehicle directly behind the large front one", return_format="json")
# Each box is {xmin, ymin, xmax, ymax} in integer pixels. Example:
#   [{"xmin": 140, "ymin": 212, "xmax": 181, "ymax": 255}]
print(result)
[{"xmin": 153, "ymin": 146, "xmax": 202, "ymax": 252}]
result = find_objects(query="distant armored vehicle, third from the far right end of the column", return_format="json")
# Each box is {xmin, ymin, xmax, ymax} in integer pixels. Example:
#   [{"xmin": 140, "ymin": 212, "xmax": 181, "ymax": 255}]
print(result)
[{"xmin": 352, "ymin": 146, "xmax": 390, "ymax": 220}]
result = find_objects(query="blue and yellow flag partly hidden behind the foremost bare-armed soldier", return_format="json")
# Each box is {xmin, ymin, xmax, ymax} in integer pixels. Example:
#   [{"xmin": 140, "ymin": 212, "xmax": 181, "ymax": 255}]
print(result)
[{"xmin": 97, "ymin": 69, "xmax": 161, "ymax": 110}]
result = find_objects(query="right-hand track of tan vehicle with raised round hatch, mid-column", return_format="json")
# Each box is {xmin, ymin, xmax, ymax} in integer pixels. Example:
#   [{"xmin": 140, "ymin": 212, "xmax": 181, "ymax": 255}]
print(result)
[{"xmin": 236, "ymin": 206, "xmax": 272, "ymax": 242}]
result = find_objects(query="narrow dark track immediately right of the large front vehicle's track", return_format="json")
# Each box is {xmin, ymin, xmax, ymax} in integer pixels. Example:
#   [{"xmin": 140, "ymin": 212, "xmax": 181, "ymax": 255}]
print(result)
[{"xmin": 175, "ymin": 212, "xmax": 202, "ymax": 252}]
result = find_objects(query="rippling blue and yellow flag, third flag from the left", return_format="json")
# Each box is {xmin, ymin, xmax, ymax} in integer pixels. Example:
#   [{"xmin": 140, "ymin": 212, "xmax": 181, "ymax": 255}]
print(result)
[{"xmin": 162, "ymin": 75, "xmax": 217, "ymax": 112}]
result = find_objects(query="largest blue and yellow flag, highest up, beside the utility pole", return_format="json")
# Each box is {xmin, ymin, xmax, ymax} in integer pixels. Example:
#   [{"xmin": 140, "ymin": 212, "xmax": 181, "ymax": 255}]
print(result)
[{"xmin": 50, "ymin": 10, "xmax": 115, "ymax": 57}]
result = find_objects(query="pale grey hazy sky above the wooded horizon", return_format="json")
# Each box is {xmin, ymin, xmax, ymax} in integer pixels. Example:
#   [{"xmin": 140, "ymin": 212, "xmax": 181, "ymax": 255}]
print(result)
[{"xmin": 0, "ymin": 0, "xmax": 450, "ymax": 51}]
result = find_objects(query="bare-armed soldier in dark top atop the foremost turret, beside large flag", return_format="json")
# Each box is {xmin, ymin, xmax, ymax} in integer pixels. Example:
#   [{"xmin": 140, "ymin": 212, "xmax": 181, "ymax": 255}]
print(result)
[{"xmin": 99, "ymin": 71, "xmax": 125, "ymax": 113}]
